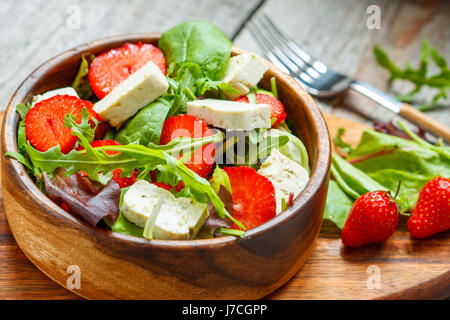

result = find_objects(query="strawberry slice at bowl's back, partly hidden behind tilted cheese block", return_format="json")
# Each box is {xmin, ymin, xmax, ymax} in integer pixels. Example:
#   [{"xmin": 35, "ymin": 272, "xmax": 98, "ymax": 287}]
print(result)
[{"xmin": 88, "ymin": 42, "xmax": 166, "ymax": 99}]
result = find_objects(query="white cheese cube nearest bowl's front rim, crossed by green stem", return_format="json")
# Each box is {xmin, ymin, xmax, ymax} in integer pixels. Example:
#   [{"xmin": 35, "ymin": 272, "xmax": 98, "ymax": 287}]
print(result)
[{"xmin": 121, "ymin": 180, "xmax": 208, "ymax": 240}]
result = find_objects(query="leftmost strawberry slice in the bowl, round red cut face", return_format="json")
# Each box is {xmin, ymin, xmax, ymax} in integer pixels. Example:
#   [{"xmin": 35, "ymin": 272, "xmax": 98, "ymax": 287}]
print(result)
[{"xmin": 25, "ymin": 95, "xmax": 101, "ymax": 153}]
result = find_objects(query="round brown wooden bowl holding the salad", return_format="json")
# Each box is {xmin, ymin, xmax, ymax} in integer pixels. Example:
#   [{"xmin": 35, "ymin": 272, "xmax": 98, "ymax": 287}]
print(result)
[{"xmin": 2, "ymin": 33, "xmax": 331, "ymax": 299}]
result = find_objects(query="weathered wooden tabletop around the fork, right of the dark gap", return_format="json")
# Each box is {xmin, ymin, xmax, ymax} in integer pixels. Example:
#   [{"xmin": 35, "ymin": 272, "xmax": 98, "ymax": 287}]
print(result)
[{"xmin": 235, "ymin": 0, "xmax": 450, "ymax": 132}]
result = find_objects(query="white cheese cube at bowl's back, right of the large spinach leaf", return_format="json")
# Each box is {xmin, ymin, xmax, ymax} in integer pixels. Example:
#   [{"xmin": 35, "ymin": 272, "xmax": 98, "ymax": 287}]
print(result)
[{"xmin": 223, "ymin": 53, "xmax": 269, "ymax": 100}]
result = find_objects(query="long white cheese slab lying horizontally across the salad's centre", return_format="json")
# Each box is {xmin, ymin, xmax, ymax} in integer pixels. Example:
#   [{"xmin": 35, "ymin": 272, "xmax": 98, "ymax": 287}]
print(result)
[{"xmin": 187, "ymin": 99, "xmax": 271, "ymax": 130}]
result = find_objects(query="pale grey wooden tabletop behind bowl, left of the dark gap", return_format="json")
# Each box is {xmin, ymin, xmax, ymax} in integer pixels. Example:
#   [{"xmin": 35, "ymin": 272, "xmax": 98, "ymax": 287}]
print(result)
[{"xmin": 0, "ymin": 0, "xmax": 258, "ymax": 110}]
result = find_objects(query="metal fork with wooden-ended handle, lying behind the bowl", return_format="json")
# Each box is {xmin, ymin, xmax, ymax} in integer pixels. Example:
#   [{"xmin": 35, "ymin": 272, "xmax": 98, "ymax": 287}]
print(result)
[{"xmin": 248, "ymin": 14, "xmax": 450, "ymax": 142}]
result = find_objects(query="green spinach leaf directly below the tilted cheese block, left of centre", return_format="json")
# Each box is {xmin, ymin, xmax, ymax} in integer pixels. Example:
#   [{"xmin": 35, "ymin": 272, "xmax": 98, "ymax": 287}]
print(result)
[{"xmin": 115, "ymin": 98, "xmax": 170, "ymax": 146}]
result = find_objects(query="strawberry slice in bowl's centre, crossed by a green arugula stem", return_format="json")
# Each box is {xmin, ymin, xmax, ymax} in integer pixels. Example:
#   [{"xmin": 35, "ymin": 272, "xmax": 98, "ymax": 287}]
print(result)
[{"xmin": 159, "ymin": 114, "xmax": 216, "ymax": 178}]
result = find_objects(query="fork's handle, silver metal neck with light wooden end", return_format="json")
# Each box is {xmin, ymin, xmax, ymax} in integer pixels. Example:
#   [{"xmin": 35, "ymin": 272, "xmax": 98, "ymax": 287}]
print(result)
[{"xmin": 350, "ymin": 81, "xmax": 450, "ymax": 142}]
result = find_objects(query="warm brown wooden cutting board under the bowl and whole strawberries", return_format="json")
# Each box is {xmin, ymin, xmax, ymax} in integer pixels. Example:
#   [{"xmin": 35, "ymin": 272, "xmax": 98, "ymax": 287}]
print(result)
[{"xmin": 0, "ymin": 114, "xmax": 450, "ymax": 299}]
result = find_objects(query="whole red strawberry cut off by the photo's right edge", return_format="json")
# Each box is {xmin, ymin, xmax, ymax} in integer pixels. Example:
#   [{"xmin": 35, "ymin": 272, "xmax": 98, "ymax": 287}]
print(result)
[{"xmin": 408, "ymin": 177, "xmax": 450, "ymax": 239}]
